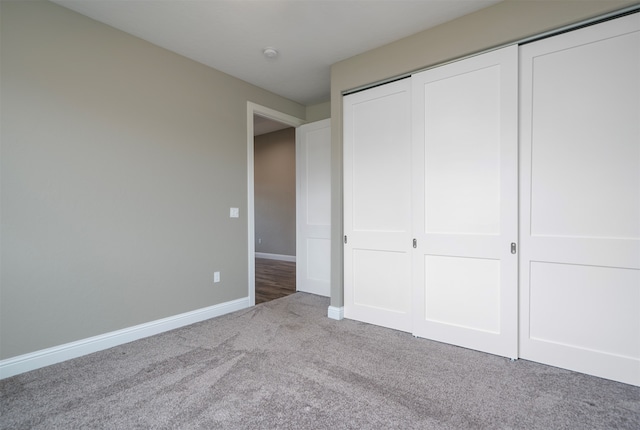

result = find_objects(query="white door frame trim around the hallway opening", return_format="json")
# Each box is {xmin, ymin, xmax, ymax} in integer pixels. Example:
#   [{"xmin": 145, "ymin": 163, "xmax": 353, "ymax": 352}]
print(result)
[{"xmin": 247, "ymin": 101, "xmax": 306, "ymax": 306}]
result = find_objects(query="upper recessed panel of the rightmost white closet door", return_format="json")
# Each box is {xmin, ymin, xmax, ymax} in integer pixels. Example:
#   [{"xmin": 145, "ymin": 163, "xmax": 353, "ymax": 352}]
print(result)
[{"xmin": 523, "ymin": 27, "xmax": 640, "ymax": 238}]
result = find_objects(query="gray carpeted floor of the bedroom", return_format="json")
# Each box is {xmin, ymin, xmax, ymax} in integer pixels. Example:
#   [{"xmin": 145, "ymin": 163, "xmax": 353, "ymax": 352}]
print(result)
[{"xmin": 0, "ymin": 293, "xmax": 640, "ymax": 430}]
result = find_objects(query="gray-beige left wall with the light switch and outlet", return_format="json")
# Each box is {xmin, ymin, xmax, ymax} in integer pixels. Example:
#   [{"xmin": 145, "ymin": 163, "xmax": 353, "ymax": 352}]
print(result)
[{"xmin": 0, "ymin": 1, "xmax": 306, "ymax": 359}]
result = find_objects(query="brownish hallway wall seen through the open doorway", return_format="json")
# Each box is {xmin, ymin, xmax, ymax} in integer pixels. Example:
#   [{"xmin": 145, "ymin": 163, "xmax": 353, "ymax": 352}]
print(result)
[{"xmin": 254, "ymin": 128, "xmax": 296, "ymax": 255}]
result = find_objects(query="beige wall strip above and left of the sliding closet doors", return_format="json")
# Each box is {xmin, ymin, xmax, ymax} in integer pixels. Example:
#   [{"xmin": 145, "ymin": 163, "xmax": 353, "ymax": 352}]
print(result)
[{"xmin": 331, "ymin": 0, "xmax": 637, "ymax": 307}]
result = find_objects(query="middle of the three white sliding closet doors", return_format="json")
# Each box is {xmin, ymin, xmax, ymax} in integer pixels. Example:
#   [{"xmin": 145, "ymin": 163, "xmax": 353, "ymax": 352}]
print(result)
[{"xmin": 413, "ymin": 46, "xmax": 518, "ymax": 358}]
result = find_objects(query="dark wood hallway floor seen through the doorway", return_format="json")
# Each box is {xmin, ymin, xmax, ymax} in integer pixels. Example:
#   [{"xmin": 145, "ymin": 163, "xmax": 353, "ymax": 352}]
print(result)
[{"xmin": 256, "ymin": 258, "xmax": 296, "ymax": 305}]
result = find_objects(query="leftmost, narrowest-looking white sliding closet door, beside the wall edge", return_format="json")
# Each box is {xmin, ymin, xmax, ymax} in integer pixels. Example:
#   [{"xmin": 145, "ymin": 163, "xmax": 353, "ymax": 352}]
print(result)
[{"xmin": 343, "ymin": 79, "xmax": 411, "ymax": 331}]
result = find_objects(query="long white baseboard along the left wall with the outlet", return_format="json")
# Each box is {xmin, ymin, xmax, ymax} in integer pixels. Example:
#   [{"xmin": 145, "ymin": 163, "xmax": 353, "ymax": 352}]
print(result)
[{"xmin": 0, "ymin": 297, "xmax": 251, "ymax": 379}]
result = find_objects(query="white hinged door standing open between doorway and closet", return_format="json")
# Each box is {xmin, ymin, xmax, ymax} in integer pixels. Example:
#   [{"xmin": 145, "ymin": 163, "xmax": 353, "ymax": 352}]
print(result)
[{"xmin": 296, "ymin": 119, "xmax": 331, "ymax": 297}]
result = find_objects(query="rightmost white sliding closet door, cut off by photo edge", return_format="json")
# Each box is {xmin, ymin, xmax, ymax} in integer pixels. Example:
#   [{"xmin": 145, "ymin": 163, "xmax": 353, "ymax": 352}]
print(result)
[{"xmin": 520, "ymin": 14, "xmax": 640, "ymax": 385}]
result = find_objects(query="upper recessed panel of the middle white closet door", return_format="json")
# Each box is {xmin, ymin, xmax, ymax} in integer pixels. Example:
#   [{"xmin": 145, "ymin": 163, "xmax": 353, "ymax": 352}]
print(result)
[{"xmin": 423, "ymin": 66, "xmax": 501, "ymax": 235}]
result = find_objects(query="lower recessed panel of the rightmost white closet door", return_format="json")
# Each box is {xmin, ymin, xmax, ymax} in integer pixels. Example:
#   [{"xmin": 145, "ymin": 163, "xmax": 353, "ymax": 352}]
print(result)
[{"xmin": 529, "ymin": 262, "xmax": 640, "ymax": 357}]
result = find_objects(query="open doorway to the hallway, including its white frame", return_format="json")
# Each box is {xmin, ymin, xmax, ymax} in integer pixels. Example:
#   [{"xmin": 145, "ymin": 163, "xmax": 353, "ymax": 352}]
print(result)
[{"xmin": 247, "ymin": 102, "xmax": 303, "ymax": 305}]
